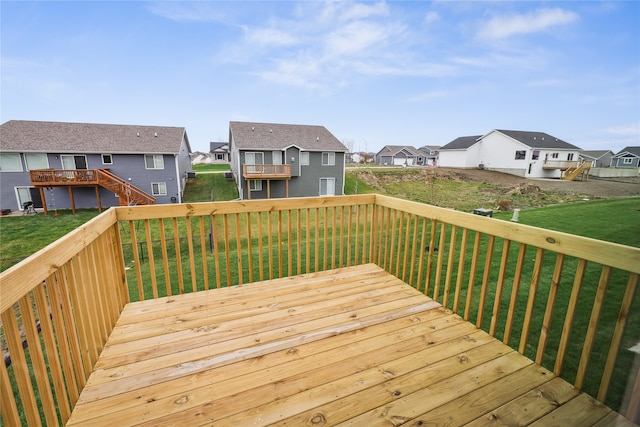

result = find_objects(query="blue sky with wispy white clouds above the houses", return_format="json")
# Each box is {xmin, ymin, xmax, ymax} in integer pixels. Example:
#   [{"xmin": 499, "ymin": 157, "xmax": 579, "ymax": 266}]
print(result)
[{"xmin": 0, "ymin": 1, "xmax": 640, "ymax": 152}]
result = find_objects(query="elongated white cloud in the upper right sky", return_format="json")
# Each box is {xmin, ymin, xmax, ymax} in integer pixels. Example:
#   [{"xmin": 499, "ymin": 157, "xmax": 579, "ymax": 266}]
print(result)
[{"xmin": 478, "ymin": 8, "xmax": 579, "ymax": 39}]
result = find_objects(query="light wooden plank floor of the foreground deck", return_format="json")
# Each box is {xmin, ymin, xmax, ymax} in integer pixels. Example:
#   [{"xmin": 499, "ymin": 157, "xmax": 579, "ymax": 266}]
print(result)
[{"xmin": 67, "ymin": 264, "xmax": 633, "ymax": 427}]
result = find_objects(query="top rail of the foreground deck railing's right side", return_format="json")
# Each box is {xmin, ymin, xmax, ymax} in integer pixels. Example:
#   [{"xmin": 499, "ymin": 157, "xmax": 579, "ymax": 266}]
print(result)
[{"xmin": 376, "ymin": 195, "xmax": 640, "ymax": 274}]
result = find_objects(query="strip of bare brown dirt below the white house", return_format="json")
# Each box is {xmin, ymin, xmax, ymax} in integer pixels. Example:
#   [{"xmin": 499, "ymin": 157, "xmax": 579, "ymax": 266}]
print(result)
[{"xmin": 438, "ymin": 168, "xmax": 640, "ymax": 199}]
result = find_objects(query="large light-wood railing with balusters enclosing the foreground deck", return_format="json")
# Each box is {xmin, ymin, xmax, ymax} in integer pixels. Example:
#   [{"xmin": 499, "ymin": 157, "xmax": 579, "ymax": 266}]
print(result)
[{"xmin": 0, "ymin": 195, "xmax": 640, "ymax": 425}]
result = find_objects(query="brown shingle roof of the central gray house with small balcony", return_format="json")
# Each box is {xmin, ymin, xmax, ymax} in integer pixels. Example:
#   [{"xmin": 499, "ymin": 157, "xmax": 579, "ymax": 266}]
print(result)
[{"xmin": 229, "ymin": 122, "xmax": 347, "ymax": 152}]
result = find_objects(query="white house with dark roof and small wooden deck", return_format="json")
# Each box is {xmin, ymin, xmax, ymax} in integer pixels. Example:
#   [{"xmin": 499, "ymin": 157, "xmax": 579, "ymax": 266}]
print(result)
[{"xmin": 439, "ymin": 129, "xmax": 581, "ymax": 178}]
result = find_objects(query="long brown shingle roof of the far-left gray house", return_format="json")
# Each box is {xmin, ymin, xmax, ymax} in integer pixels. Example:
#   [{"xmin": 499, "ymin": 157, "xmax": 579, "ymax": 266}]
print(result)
[{"xmin": 0, "ymin": 120, "xmax": 191, "ymax": 154}]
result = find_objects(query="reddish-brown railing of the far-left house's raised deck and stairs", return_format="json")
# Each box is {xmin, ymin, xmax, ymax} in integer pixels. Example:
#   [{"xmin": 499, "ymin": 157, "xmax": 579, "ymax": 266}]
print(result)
[{"xmin": 29, "ymin": 169, "xmax": 156, "ymax": 206}]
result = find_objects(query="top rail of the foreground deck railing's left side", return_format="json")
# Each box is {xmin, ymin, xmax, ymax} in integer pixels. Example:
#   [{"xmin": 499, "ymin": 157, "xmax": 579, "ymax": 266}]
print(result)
[{"xmin": 0, "ymin": 209, "xmax": 117, "ymax": 313}]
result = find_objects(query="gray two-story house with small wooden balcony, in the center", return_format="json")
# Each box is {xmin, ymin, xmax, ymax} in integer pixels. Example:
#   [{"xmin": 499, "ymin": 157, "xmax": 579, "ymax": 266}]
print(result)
[{"xmin": 229, "ymin": 122, "xmax": 347, "ymax": 199}]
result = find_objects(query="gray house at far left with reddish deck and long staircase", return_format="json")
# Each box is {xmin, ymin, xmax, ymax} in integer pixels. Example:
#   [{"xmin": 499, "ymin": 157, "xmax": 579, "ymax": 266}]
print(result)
[{"xmin": 0, "ymin": 120, "xmax": 191, "ymax": 211}]
